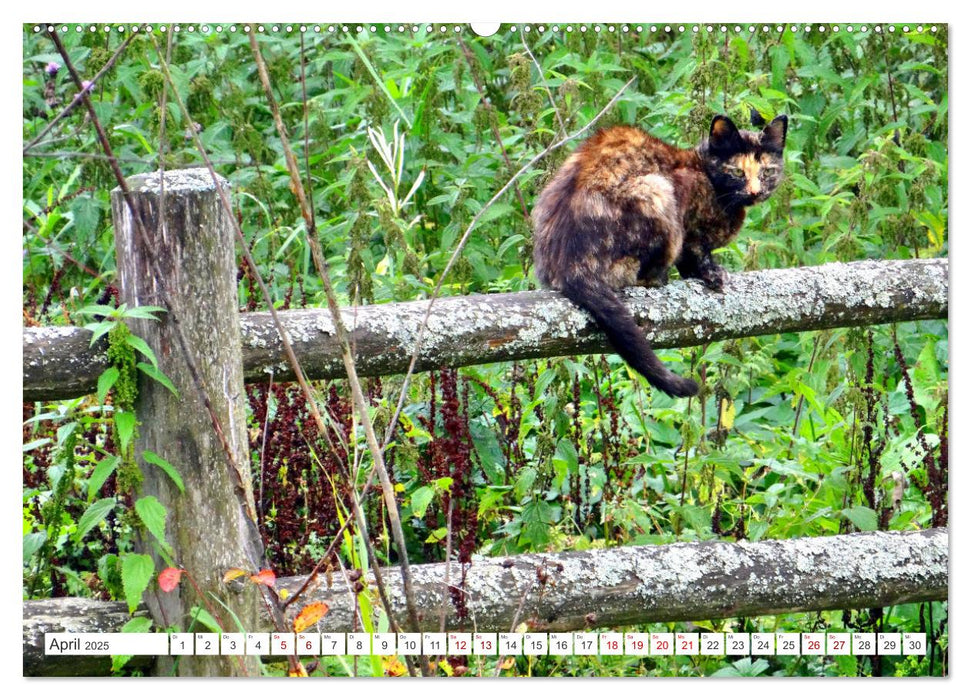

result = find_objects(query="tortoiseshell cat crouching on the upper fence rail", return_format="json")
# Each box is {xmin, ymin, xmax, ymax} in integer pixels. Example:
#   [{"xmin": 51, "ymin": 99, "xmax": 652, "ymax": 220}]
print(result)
[{"xmin": 533, "ymin": 111, "xmax": 788, "ymax": 396}]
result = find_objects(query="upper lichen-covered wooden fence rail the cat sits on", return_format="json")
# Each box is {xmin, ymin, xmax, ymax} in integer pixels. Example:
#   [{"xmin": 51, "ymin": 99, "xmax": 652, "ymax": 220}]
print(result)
[{"xmin": 23, "ymin": 259, "xmax": 948, "ymax": 401}]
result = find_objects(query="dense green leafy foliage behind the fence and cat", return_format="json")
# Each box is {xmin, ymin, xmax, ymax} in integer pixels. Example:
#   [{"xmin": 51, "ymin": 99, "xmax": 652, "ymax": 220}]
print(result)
[{"xmin": 23, "ymin": 25, "xmax": 948, "ymax": 675}]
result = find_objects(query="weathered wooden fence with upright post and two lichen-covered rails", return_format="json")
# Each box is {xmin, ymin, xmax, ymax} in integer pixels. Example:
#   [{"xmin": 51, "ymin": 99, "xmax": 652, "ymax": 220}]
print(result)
[{"xmin": 23, "ymin": 170, "xmax": 948, "ymax": 675}]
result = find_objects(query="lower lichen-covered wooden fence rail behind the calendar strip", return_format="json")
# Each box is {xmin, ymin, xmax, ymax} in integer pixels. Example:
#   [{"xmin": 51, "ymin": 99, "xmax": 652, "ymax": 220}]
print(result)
[{"xmin": 23, "ymin": 528, "xmax": 948, "ymax": 675}]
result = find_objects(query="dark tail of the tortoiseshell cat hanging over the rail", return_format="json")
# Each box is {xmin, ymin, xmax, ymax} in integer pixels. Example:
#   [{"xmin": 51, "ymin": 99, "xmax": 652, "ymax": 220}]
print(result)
[{"xmin": 561, "ymin": 278, "xmax": 698, "ymax": 396}]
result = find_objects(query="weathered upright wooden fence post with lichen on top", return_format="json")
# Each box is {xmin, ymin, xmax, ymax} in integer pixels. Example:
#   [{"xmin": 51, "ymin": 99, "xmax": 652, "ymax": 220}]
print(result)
[{"xmin": 111, "ymin": 168, "xmax": 263, "ymax": 676}]
